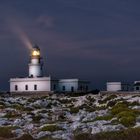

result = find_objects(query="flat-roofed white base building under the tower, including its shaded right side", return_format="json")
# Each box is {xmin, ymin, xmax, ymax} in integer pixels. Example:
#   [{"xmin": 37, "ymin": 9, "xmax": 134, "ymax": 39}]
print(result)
[{"xmin": 10, "ymin": 77, "xmax": 58, "ymax": 92}]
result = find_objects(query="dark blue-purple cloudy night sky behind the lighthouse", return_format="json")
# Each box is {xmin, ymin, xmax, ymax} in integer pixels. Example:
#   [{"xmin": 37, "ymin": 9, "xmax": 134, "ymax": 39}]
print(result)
[{"xmin": 0, "ymin": 0, "xmax": 140, "ymax": 90}]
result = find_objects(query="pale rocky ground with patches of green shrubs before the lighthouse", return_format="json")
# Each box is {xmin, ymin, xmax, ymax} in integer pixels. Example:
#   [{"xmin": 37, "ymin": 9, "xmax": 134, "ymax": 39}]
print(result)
[{"xmin": 0, "ymin": 94, "xmax": 140, "ymax": 140}]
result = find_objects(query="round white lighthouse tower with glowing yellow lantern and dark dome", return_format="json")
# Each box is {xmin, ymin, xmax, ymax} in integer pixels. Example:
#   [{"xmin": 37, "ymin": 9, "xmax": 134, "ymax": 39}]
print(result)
[{"xmin": 29, "ymin": 45, "xmax": 43, "ymax": 77}]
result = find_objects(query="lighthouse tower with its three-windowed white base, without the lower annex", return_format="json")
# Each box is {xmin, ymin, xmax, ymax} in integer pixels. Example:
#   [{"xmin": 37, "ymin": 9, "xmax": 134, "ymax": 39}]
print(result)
[{"xmin": 10, "ymin": 46, "xmax": 58, "ymax": 93}]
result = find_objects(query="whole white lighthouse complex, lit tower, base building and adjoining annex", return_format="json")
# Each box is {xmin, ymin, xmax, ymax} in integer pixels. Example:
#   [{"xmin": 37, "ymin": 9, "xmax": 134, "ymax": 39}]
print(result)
[{"xmin": 10, "ymin": 46, "xmax": 89, "ymax": 94}]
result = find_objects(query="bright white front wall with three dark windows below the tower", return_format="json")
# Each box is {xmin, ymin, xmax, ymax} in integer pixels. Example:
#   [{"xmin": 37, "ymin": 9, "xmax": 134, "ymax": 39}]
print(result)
[{"xmin": 10, "ymin": 78, "xmax": 51, "ymax": 92}]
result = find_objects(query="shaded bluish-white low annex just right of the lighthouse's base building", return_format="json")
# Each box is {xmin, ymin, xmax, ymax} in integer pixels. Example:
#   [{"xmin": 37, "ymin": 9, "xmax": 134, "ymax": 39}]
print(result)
[{"xmin": 59, "ymin": 79, "xmax": 89, "ymax": 92}]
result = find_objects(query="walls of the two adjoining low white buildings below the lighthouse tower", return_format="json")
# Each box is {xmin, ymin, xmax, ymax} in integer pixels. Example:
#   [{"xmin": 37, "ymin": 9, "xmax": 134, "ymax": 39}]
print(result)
[{"xmin": 10, "ymin": 77, "xmax": 89, "ymax": 92}]
